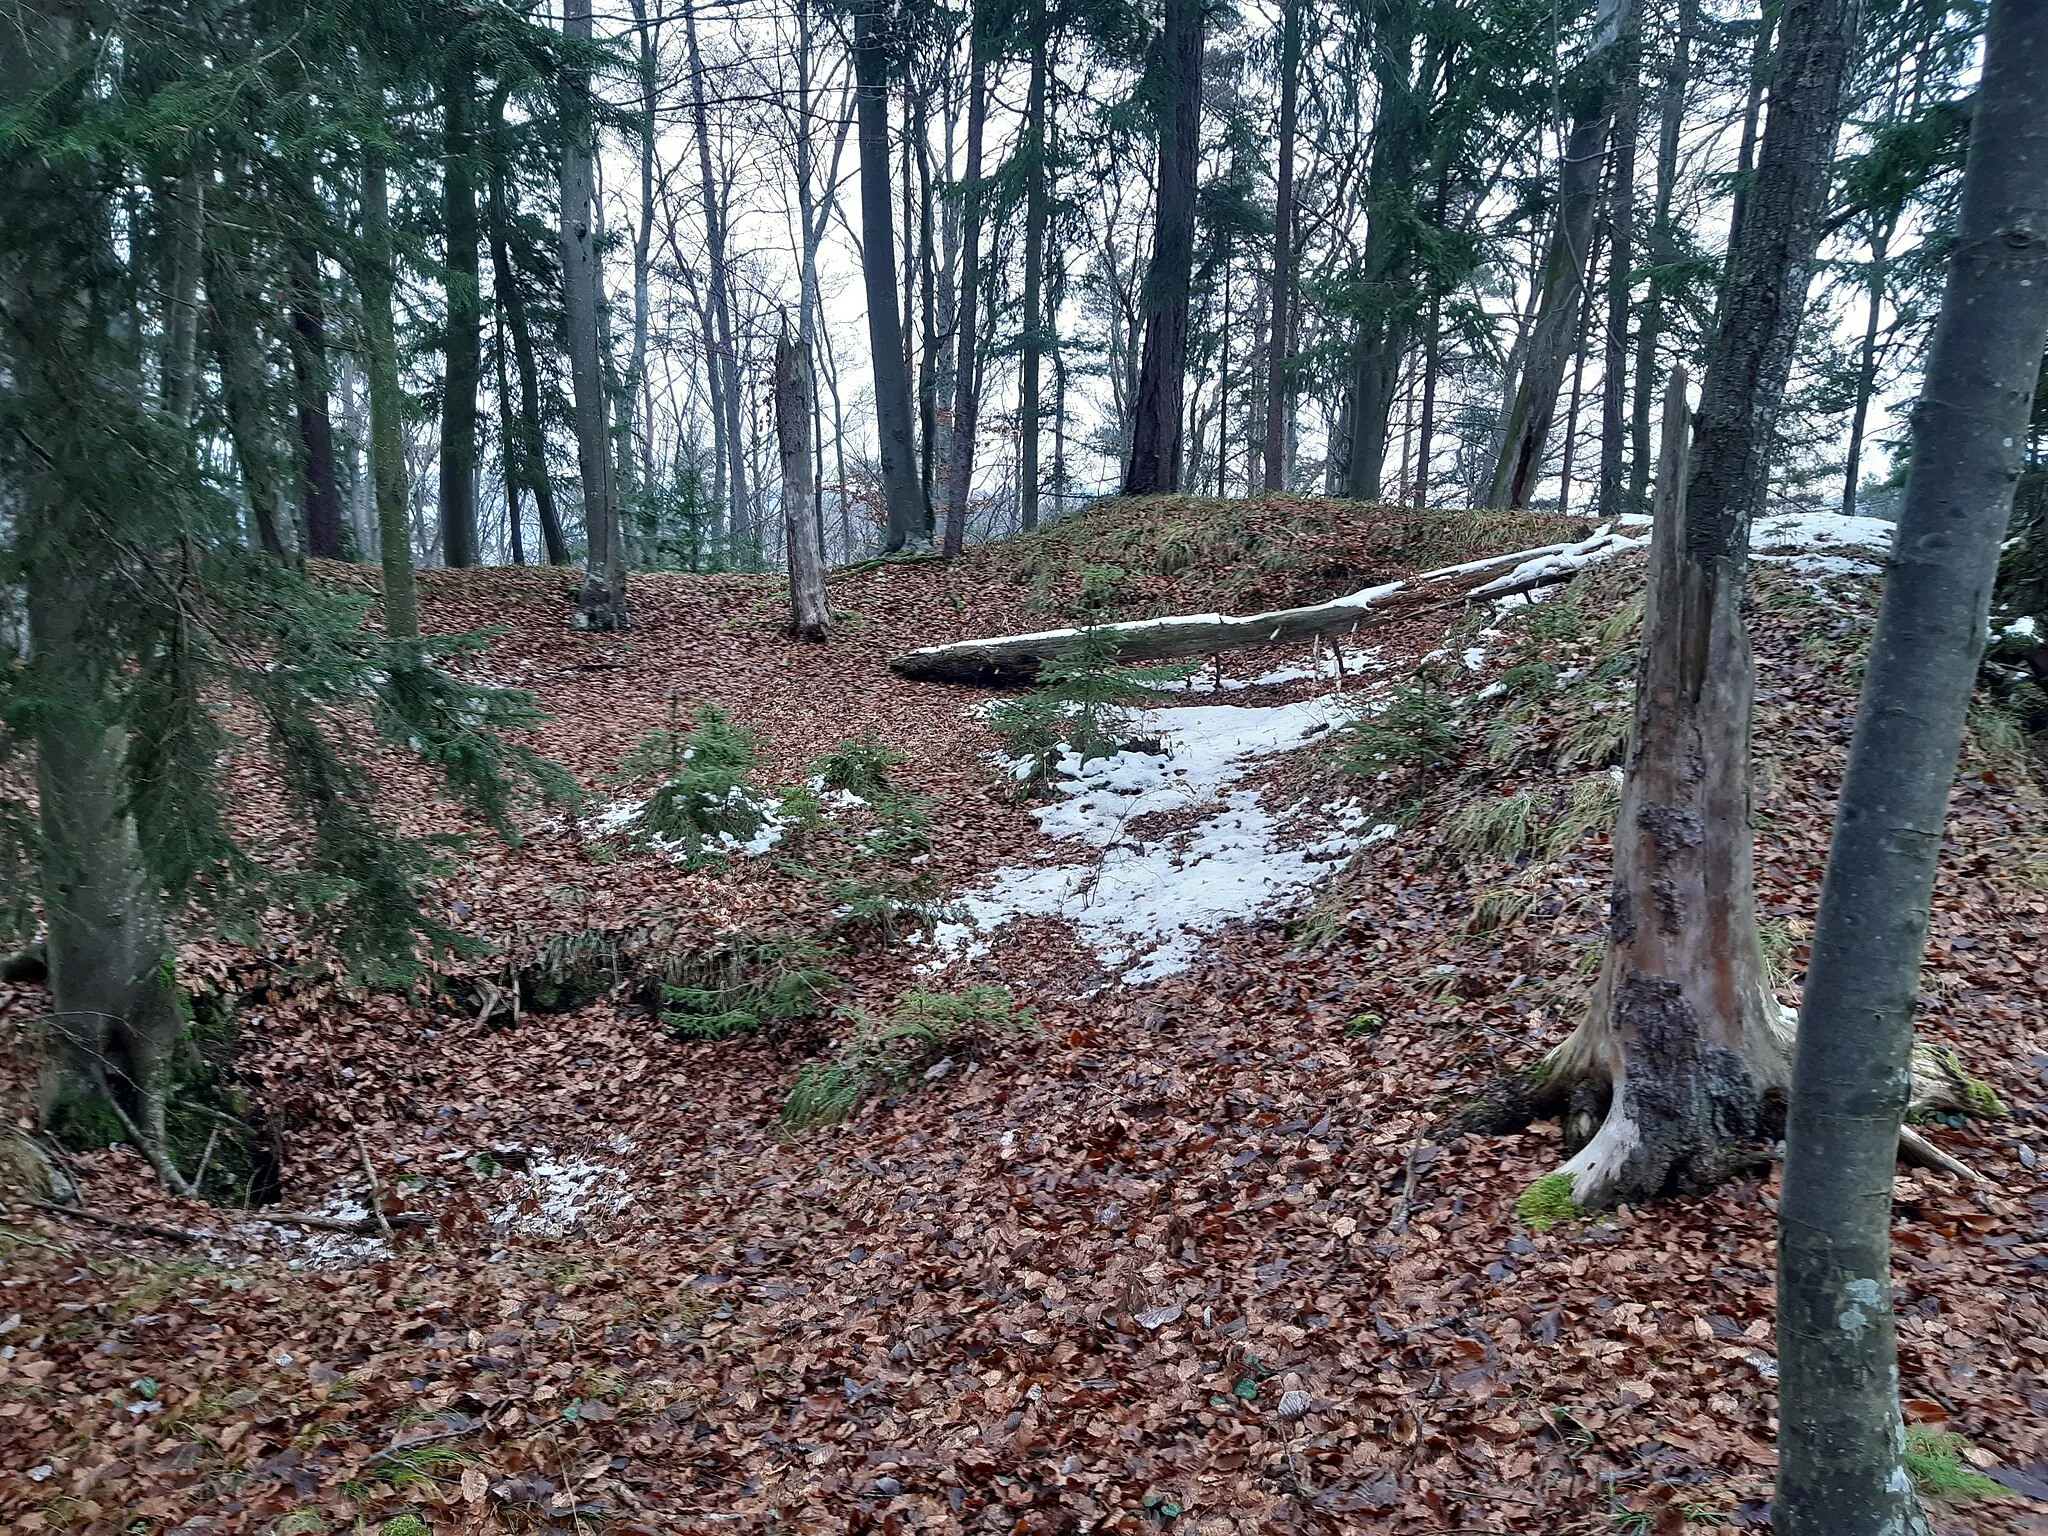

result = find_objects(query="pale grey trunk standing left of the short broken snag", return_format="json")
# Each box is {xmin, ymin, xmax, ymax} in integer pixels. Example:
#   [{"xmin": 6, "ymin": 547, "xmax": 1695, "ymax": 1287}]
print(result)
[{"xmin": 561, "ymin": 0, "xmax": 631, "ymax": 629}]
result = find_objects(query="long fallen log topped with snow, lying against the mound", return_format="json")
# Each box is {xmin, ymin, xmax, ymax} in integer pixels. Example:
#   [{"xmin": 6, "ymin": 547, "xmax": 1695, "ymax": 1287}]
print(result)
[{"xmin": 889, "ymin": 528, "xmax": 1649, "ymax": 688}]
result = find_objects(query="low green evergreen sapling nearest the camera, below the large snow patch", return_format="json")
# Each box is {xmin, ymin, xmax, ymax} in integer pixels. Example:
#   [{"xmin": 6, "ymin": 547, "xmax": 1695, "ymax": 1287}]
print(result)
[{"xmin": 782, "ymin": 985, "xmax": 1032, "ymax": 1130}]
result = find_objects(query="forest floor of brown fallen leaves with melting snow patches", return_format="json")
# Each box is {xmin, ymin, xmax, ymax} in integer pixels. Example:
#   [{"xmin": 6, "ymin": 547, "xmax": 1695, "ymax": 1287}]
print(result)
[{"xmin": 0, "ymin": 498, "xmax": 2048, "ymax": 1536}]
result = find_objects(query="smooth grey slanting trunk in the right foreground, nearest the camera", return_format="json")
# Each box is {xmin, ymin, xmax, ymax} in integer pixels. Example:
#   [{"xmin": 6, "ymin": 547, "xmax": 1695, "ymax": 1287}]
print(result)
[{"xmin": 1772, "ymin": 0, "xmax": 2048, "ymax": 1536}]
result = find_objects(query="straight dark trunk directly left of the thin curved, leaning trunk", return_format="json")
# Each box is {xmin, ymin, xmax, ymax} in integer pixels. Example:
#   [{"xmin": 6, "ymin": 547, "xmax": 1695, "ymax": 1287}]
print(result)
[{"xmin": 440, "ymin": 41, "xmax": 483, "ymax": 569}]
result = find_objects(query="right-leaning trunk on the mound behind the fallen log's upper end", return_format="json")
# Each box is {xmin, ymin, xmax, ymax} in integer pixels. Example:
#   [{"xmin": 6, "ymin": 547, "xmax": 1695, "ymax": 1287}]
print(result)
[{"xmin": 1487, "ymin": 0, "xmax": 1630, "ymax": 508}]
